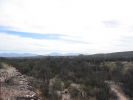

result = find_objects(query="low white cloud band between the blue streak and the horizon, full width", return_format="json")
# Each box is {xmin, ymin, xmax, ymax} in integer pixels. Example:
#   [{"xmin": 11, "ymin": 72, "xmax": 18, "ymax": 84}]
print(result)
[{"xmin": 0, "ymin": 33, "xmax": 133, "ymax": 54}]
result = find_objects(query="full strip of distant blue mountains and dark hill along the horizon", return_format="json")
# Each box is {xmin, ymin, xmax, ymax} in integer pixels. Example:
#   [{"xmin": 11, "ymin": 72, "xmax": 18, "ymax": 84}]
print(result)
[{"xmin": 0, "ymin": 51, "xmax": 133, "ymax": 58}]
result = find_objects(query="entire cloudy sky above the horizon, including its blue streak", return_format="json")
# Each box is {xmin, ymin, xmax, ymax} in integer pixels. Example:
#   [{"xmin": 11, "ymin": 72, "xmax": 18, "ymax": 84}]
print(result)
[{"xmin": 0, "ymin": 0, "xmax": 133, "ymax": 54}]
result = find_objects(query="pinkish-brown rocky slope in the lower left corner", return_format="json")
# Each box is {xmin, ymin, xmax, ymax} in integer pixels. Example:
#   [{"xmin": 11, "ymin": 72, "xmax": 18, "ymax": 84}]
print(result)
[{"xmin": 0, "ymin": 63, "xmax": 41, "ymax": 100}]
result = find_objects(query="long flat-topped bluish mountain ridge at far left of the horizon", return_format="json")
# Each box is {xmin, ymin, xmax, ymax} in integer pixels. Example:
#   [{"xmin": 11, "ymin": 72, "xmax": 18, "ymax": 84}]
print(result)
[{"xmin": 0, "ymin": 53, "xmax": 37, "ymax": 57}]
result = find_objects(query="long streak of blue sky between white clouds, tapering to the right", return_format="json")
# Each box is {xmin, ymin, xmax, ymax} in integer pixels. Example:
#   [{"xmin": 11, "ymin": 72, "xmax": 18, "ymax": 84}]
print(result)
[{"xmin": 0, "ymin": 26, "xmax": 90, "ymax": 44}]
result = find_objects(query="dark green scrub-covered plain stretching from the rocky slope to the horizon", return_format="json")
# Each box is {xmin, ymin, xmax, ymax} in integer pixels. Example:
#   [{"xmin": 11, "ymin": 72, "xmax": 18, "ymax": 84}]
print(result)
[{"xmin": 0, "ymin": 52, "xmax": 133, "ymax": 100}]
